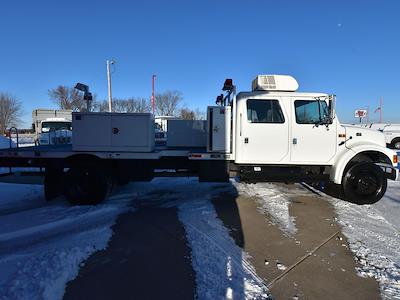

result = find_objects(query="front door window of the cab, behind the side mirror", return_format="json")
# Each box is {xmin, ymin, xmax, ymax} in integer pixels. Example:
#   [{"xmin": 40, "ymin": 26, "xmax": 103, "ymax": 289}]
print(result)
[{"xmin": 294, "ymin": 100, "xmax": 328, "ymax": 124}]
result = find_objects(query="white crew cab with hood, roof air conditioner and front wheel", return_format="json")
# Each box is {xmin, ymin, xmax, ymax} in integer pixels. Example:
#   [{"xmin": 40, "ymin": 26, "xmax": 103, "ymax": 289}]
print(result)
[{"xmin": 209, "ymin": 75, "xmax": 398, "ymax": 204}]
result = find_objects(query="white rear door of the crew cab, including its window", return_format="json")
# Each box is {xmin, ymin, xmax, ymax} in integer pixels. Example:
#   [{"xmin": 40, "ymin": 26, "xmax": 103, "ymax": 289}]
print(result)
[{"xmin": 236, "ymin": 97, "xmax": 289, "ymax": 164}]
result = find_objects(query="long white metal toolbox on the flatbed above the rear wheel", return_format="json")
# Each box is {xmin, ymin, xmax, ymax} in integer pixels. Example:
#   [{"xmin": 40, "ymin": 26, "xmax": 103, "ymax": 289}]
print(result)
[{"xmin": 72, "ymin": 112, "xmax": 154, "ymax": 152}]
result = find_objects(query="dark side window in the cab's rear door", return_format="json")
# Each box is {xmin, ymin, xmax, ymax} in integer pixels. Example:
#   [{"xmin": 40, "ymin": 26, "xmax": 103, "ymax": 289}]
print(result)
[{"xmin": 247, "ymin": 99, "xmax": 285, "ymax": 123}]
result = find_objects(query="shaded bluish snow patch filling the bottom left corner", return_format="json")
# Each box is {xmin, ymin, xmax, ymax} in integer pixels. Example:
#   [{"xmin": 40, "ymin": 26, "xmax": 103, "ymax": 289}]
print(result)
[{"xmin": 0, "ymin": 226, "xmax": 112, "ymax": 300}]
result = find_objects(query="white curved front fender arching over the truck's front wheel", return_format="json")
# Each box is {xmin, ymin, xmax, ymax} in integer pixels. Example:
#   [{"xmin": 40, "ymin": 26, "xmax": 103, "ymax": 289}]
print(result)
[{"xmin": 329, "ymin": 144, "xmax": 397, "ymax": 184}]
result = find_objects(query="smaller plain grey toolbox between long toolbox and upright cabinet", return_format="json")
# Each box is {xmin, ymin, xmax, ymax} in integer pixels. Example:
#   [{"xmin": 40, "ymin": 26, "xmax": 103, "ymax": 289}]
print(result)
[{"xmin": 167, "ymin": 120, "xmax": 207, "ymax": 147}]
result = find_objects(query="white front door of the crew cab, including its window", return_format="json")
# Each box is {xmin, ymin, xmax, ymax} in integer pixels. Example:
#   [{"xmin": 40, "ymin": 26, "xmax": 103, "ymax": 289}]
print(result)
[{"xmin": 290, "ymin": 98, "xmax": 337, "ymax": 165}]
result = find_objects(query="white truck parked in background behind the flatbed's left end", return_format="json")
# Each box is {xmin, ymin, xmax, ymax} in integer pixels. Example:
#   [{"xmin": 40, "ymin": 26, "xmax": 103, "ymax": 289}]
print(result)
[{"xmin": 32, "ymin": 109, "xmax": 72, "ymax": 145}]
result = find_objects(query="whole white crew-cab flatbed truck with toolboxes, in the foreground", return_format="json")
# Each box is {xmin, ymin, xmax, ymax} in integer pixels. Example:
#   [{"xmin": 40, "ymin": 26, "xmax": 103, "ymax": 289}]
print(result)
[{"xmin": 0, "ymin": 75, "xmax": 399, "ymax": 204}]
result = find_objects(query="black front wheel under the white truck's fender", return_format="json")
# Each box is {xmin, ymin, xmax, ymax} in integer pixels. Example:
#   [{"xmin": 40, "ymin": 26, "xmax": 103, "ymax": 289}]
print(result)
[{"xmin": 343, "ymin": 162, "xmax": 387, "ymax": 205}]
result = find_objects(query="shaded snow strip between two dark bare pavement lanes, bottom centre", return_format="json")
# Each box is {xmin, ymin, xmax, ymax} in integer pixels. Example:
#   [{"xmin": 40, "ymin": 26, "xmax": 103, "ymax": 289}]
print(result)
[{"xmin": 179, "ymin": 199, "xmax": 269, "ymax": 299}]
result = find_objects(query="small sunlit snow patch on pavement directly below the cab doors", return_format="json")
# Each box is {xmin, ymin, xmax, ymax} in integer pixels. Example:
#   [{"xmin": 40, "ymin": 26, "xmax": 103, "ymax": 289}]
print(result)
[{"xmin": 232, "ymin": 181, "xmax": 308, "ymax": 235}]
